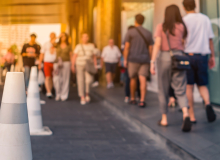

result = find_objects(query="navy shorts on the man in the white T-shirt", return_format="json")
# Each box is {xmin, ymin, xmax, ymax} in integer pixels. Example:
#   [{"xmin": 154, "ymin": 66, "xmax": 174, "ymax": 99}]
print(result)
[{"xmin": 186, "ymin": 54, "xmax": 208, "ymax": 86}]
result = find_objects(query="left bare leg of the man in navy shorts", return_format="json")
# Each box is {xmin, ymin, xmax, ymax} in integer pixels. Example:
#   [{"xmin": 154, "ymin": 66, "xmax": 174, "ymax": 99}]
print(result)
[{"xmin": 186, "ymin": 85, "xmax": 196, "ymax": 121}]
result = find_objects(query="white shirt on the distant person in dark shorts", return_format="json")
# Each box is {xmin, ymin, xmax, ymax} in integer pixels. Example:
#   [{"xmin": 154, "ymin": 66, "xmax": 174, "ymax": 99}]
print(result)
[{"xmin": 102, "ymin": 46, "xmax": 121, "ymax": 63}]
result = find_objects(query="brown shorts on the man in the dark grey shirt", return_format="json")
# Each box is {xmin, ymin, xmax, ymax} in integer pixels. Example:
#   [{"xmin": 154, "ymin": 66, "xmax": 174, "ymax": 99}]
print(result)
[{"xmin": 128, "ymin": 62, "xmax": 150, "ymax": 78}]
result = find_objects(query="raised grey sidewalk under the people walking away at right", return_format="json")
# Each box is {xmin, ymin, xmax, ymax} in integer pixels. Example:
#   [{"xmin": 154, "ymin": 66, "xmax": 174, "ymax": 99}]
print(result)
[{"xmin": 94, "ymin": 87, "xmax": 220, "ymax": 160}]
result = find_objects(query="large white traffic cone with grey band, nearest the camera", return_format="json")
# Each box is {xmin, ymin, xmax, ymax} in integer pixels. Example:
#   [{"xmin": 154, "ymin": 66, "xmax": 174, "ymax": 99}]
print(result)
[{"xmin": 0, "ymin": 72, "xmax": 33, "ymax": 160}]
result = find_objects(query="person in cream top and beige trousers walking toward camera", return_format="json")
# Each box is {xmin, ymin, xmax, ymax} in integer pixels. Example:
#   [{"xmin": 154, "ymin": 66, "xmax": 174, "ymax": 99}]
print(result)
[{"xmin": 72, "ymin": 33, "xmax": 97, "ymax": 105}]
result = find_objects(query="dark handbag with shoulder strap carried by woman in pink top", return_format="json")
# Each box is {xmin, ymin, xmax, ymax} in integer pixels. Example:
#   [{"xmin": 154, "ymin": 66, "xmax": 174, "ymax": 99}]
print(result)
[{"xmin": 166, "ymin": 32, "xmax": 191, "ymax": 71}]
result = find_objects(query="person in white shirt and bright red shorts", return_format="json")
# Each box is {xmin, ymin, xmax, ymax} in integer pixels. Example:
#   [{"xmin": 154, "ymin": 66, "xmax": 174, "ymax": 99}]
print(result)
[{"xmin": 38, "ymin": 33, "xmax": 56, "ymax": 98}]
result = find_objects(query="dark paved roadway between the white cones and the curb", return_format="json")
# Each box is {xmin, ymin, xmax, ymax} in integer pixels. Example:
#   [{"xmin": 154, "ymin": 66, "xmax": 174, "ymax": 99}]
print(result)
[{"xmin": 1, "ymin": 87, "xmax": 198, "ymax": 160}]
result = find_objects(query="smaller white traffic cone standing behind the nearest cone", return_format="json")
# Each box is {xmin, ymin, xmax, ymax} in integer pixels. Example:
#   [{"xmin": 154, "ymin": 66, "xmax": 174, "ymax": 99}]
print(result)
[{"xmin": 27, "ymin": 67, "xmax": 53, "ymax": 136}]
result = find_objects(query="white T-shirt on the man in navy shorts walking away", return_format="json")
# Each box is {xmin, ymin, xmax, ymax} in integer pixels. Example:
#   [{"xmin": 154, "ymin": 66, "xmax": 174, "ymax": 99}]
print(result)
[{"xmin": 183, "ymin": 13, "xmax": 214, "ymax": 55}]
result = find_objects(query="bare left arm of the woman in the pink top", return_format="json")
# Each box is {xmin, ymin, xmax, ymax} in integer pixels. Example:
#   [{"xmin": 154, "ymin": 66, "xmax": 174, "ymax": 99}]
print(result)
[{"xmin": 150, "ymin": 37, "xmax": 161, "ymax": 75}]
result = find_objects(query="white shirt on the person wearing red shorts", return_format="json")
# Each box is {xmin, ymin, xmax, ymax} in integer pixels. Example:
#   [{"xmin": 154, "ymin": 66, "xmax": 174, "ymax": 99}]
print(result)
[{"xmin": 41, "ymin": 42, "xmax": 56, "ymax": 63}]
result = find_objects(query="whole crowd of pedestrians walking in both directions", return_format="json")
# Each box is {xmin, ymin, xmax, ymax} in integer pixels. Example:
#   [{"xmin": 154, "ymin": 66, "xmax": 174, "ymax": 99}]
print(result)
[{"xmin": 13, "ymin": 0, "xmax": 216, "ymax": 132}]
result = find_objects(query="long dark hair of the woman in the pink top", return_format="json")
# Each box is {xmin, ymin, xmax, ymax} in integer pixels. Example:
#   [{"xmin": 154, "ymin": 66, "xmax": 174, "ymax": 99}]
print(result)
[{"xmin": 163, "ymin": 5, "xmax": 188, "ymax": 38}]
